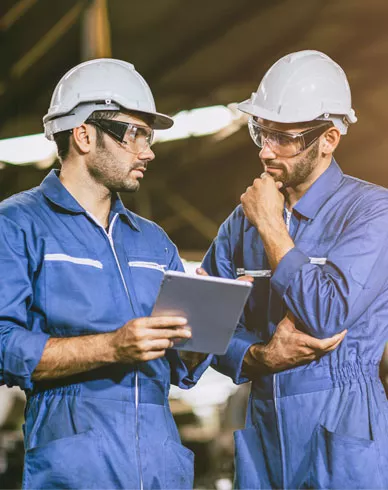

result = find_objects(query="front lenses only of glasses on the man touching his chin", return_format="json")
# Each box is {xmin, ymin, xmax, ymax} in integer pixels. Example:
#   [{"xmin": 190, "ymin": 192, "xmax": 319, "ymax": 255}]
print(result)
[{"xmin": 248, "ymin": 119, "xmax": 304, "ymax": 157}]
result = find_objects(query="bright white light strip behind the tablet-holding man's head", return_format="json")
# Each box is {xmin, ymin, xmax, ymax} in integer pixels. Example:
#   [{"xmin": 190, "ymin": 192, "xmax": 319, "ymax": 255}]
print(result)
[{"xmin": 0, "ymin": 104, "xmax": 241, "ymax": 165}]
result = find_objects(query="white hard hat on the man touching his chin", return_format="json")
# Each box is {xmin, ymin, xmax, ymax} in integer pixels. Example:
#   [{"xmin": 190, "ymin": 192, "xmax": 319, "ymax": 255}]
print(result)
[{"xmin": 238, "ymin": 50, "xmax": 357, "ymax": 134}]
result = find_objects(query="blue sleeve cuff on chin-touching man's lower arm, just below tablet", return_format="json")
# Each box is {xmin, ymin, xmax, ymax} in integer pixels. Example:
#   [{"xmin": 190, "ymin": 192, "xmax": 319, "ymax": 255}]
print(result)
[{"xmin": 212, "ymin": 328, "xmax": 261, "ymax": 384}]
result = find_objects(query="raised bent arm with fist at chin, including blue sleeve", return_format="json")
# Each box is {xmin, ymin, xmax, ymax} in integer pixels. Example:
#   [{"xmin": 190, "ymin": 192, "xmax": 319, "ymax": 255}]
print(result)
[{"xmin": 241, "ymin": 176, "xmax": 388, "ymax": 338}]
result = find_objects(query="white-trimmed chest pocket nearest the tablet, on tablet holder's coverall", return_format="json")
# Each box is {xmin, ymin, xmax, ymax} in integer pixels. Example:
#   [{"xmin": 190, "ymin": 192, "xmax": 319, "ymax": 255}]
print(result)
[{"xmin": 128, "ymin": 255, "xmax": 167, "ymax": 316}]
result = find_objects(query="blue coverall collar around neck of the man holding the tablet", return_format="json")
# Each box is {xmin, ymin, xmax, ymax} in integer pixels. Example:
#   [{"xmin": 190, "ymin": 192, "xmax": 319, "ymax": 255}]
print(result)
[{"xmin": 40, "ymin": 170, "xmax": 140, "ymax": 231}]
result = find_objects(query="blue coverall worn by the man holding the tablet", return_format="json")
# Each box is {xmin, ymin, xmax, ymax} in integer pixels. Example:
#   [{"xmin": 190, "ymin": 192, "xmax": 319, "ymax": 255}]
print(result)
[{"xmin": 0, "ymin": 171, "xmax": 197, "ymax": 489}]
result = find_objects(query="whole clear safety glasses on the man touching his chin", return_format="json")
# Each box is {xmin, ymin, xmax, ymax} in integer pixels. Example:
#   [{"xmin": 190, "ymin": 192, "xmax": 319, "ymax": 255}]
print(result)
[{"xmin": 248, "ymin": 117, "xmax": 332, "ymax": 158}]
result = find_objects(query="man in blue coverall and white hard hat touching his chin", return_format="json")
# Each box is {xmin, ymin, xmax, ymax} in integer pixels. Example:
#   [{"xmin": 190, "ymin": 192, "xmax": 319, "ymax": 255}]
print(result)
[{"xmin": 203, "ymin": 51, "xmax": 388, "ymax": 489}]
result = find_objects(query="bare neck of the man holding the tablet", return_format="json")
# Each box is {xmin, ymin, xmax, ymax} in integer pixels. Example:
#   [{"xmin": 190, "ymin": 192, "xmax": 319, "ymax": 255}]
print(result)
[{"xmin": 59, "ymin": 160, "xmax": 112, "ymax": 228}]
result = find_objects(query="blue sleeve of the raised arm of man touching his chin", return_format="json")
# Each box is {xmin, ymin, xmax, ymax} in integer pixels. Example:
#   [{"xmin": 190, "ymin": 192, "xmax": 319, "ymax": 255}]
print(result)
[{"xmin": 271, "ymin": 202, "xmax": 388, "ymax": 338}]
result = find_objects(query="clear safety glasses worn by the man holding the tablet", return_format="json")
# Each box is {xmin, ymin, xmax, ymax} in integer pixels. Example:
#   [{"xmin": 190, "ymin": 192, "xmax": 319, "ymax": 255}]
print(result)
[{"xmin": 85, "ymin": 119, "xmax": 154, "ymax": 154}]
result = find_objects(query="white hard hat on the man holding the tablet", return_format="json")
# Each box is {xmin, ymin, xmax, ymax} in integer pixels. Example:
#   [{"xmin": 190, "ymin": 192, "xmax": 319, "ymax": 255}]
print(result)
[{"xmin": 43, "ymin": 58, "xmax": 174, "ymax": 140}]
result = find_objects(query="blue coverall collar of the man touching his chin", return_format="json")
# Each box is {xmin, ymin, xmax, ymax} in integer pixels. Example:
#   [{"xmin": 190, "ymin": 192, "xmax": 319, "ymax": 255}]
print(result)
[{"xmin": 294, "ymin": 158, "xmax": 343, "ymax": 219}]
